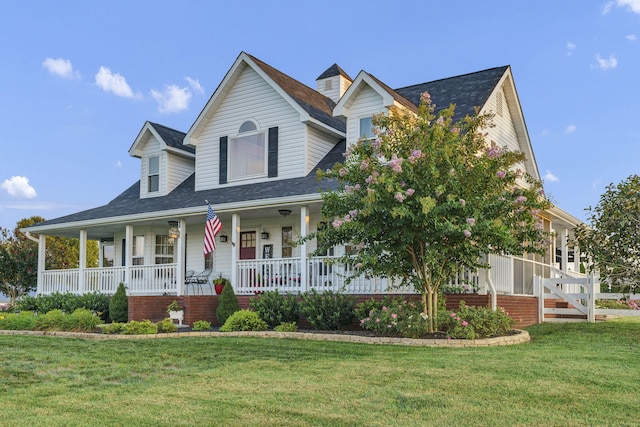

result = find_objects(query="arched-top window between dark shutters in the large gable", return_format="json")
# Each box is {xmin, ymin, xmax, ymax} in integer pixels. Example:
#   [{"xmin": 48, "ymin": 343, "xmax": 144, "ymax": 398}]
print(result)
[{"xmin": 228, "ymin": 120, "xmax": 267, "ymax": 179}]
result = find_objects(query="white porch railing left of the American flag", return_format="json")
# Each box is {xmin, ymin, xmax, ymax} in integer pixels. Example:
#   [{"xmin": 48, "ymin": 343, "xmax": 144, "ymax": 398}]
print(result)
[{"xmin": 39, "ymin": 264, "xmax": 178, "ymax": 295}]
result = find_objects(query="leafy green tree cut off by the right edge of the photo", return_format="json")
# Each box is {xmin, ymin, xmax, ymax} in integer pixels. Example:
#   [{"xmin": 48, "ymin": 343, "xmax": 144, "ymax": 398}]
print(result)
[{"xmin": 575, "ymin": 175, "xmax": 640, "ymax": 292}]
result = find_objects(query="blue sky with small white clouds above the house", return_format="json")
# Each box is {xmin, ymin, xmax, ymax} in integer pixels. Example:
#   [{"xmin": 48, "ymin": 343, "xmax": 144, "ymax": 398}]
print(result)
[{"xmin": 0, "ymin": 0, "xmax": 640, "ymax": 228}]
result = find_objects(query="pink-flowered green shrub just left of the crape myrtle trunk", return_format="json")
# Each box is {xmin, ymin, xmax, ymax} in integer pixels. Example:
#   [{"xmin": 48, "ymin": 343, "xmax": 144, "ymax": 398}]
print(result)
[{"xmin": 356, "ymin": 296, "xmax": 429, "ymax": 338}]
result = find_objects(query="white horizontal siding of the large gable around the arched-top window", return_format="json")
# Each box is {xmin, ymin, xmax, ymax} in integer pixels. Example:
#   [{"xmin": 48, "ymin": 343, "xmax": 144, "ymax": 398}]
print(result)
[{"xmin": 195, "ymin": 66, "xmax": 305, "ymax": 191}]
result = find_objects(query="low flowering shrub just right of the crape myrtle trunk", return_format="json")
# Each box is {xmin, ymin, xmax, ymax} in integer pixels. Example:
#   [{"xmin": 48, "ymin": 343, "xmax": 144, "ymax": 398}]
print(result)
[{"xmin": 438, "ymin": 301, "xmax": 514, "ymax": 339}]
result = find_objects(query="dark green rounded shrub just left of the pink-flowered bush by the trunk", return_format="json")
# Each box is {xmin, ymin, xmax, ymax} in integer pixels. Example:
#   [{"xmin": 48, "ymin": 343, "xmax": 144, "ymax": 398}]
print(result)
[{"xmin": 300, "ymin": 289, "xmax": 357, "ymax": 330}]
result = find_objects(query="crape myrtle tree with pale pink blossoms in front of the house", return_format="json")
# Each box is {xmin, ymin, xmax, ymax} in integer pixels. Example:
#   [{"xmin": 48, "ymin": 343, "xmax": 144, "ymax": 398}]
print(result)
[{"xmin": 310, "ymin": 93, "xmax": 549, "ymax": 332}]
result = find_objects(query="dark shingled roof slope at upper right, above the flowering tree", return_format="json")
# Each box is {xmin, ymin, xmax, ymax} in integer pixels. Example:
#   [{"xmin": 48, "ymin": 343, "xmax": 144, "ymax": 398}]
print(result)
[{"xmin": 396, "ymin": 66, "xmax": 509, "ymax": 120}]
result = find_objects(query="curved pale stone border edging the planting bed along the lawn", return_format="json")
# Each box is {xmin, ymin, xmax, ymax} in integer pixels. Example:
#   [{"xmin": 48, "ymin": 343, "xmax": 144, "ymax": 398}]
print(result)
[{"xmin": 0, "ymin": 329, "xmax": 531, "ymax": 347}]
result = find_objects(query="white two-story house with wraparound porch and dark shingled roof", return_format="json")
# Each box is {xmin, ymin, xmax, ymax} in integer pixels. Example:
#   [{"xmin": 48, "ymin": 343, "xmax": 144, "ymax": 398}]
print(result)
[{"xmin": 25, "ymin": 52, "xmax": 578, "ymax": 326}]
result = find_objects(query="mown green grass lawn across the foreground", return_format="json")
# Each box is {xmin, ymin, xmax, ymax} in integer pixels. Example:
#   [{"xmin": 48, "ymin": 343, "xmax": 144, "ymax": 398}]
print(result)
[{"xmin": 0, "ymin": 320, "xmax": 640, "ymax": 426}]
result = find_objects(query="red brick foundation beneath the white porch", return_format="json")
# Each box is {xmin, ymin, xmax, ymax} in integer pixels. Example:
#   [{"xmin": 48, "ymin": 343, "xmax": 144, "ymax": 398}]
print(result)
[{"xmin": 129, "ymin": 294, "xmax": 539, "ymax": 329}]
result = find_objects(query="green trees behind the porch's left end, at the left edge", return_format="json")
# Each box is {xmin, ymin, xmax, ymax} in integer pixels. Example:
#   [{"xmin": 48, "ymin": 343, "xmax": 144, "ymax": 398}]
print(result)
[{"xmin": 0, "ymin": 216, "xmax": 98, "ymax": 301}]
